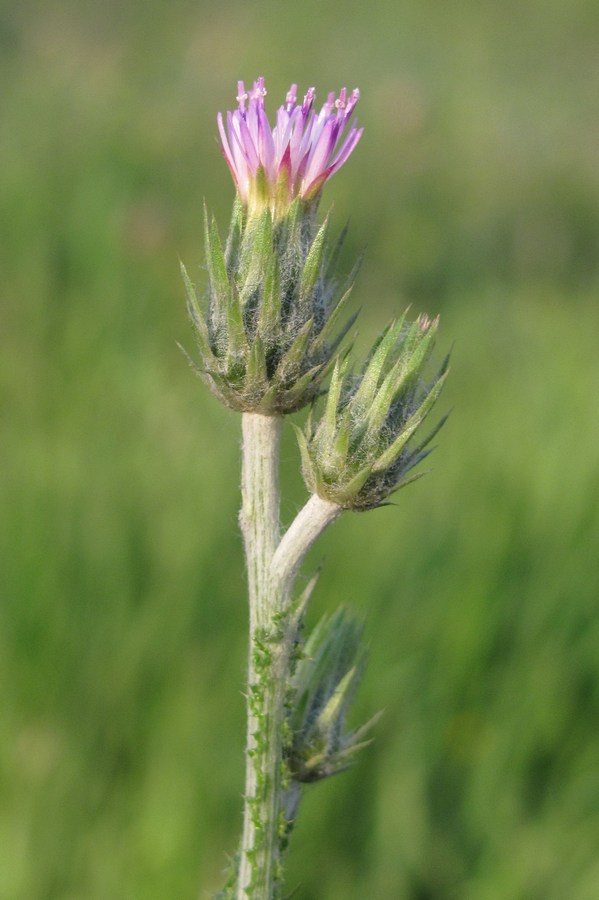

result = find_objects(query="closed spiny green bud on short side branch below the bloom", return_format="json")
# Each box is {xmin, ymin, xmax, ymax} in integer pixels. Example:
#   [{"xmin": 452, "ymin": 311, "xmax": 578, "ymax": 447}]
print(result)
[{"xmin": 296, "ymin": 314, "xmax": 448, "ymax": 510}]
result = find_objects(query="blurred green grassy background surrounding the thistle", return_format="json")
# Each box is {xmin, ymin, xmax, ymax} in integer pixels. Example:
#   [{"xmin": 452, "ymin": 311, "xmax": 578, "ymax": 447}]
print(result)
[{"xmin": 0, "ymin": 0, "xmax": 599, "ymax": 900}]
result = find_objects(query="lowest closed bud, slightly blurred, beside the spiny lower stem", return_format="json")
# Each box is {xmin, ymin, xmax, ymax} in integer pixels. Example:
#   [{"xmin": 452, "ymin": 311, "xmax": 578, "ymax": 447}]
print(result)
[{"xmin": 287, "ymin": 609, "xmax": 379, "ymax": 782}]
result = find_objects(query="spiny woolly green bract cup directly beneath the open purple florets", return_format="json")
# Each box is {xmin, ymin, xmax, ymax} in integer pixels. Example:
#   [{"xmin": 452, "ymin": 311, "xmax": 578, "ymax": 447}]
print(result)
[{"xmin": 183, "ymin": 199, "xmax": 355, "ymax": 415}]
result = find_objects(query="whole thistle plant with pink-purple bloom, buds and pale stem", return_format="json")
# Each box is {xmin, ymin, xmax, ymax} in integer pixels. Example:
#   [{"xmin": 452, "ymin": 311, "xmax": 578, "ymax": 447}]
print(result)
[{"xmin": 183, "ymin": 78, "xmax": 447, "ymax": 900}]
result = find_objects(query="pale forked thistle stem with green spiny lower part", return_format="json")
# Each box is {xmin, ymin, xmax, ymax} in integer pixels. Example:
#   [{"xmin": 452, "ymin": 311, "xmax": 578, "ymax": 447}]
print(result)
[{"xmin": 236, "ymin": 413, "xmax": 341, "ymax": 900}]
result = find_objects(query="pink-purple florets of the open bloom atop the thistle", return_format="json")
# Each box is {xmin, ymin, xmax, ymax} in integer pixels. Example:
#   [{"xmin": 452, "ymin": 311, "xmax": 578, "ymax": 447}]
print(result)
[{"xmin": 218, "ymin": 78, "xmax": 362, "ymax": 218}]
